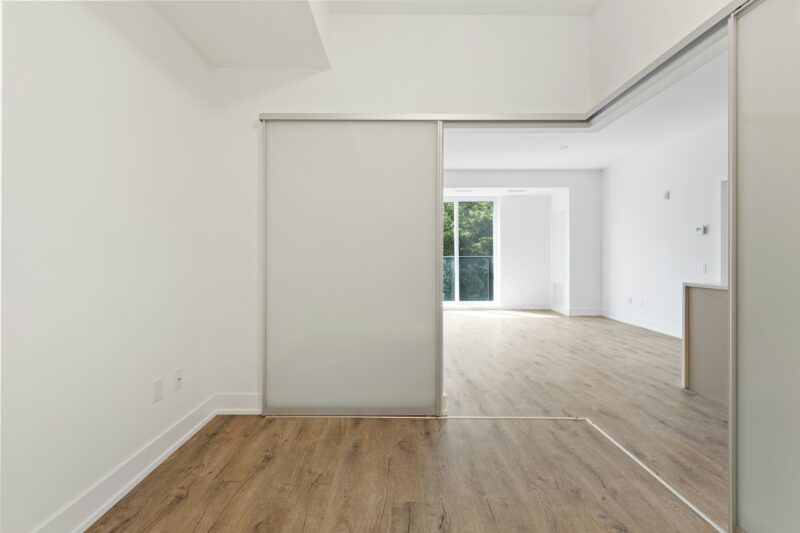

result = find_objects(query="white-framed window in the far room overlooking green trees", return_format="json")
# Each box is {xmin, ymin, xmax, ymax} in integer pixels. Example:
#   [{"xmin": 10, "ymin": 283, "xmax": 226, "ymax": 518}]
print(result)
[{"xmin": 442, "ymin": 201, "xmax": 494, "ymax": 302}]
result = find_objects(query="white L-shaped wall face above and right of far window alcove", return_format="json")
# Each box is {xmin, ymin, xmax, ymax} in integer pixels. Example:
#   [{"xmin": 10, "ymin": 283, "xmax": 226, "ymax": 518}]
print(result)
[{"xmin": 444, "ymin": 170, "xmax": 601, "ymax": 315}]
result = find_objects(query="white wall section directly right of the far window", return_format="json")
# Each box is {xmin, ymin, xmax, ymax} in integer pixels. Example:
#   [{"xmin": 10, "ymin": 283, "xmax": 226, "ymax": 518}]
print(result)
[{"xmin": 498, "ymin": 196, "xmax": 550, "ymax": 309}]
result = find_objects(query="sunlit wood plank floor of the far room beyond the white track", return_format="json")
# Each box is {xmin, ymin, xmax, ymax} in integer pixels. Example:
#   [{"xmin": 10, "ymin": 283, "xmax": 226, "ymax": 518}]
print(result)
[{"xmin": 444, "ymin": 311, "xmax": 728, "ymax": 525}]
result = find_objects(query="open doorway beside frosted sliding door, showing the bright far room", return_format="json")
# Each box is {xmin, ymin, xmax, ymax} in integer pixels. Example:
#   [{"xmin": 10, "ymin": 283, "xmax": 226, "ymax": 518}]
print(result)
[{"xmin": 443, "ymin": 30, "xmax": 730, "ymax": 530}]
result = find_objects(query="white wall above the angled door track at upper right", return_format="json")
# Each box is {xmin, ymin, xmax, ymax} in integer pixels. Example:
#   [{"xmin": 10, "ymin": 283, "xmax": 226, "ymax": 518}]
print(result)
[{"xmin": 591, "ymin": 0, "xmax": 731, "ymax": 105}]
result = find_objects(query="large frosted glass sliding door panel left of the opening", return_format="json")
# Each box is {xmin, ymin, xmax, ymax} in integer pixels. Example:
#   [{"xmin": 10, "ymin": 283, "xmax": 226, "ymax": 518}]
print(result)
[{"xmin": 265, "ymin": 120, "xmax": 441, "ymax": 415}]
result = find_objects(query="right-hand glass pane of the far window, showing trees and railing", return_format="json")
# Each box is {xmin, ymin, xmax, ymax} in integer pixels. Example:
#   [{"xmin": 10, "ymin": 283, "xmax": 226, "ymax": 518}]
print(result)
[{"xmin": 458, "ymin": 202, "xmax": 494, "ymax": 302}]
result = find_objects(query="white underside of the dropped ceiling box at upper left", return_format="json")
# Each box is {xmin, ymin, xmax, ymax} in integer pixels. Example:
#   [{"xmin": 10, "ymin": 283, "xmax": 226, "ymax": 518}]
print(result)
[{"xmin": 151, "ymin": 0, "xmax": 330, "ymax": 68}]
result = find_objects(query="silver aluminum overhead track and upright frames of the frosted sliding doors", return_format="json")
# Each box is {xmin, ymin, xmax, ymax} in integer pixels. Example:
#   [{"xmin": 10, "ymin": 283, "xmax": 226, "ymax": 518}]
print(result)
[{"xmin": 259, "ymin": 0, "xmax": 752, "ymax": 533}]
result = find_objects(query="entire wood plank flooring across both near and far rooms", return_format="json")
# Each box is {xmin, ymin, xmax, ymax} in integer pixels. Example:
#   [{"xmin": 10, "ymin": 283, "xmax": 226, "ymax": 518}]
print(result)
[{"xmin": 89, "ymin": 311, "xmax": 727, "ymax": 533}]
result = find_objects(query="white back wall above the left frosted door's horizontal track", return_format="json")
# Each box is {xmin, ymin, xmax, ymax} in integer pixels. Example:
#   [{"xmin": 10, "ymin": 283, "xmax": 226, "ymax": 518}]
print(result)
[{"xmin": 212, "ymin": 14, "xmax": 590, "ymax": 113}]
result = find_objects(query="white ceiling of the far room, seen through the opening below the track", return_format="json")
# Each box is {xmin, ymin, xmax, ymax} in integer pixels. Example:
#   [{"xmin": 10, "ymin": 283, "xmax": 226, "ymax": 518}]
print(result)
[{"xmin": 444, "ymin": 53, "xmax": 728, "ymax": 169}]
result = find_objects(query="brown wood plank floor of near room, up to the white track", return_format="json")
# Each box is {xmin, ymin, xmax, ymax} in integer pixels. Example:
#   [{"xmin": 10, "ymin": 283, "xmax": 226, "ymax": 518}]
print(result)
[{"xmin": 89, "ymin": 416, "xmax": 713, "ymax": 533}]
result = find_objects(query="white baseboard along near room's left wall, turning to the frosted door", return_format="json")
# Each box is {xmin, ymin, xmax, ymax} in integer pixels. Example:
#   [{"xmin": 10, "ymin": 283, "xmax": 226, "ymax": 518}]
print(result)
[{"xmin": 33, "ymin": 393, "xmax": 261, "ymax": 533}]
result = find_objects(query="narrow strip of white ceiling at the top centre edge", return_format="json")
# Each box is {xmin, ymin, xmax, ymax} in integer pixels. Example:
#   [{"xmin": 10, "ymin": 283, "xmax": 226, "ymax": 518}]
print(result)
[{"xmin": 328, "ymin": 0, "xmax": 600, "ymax": 16}]
